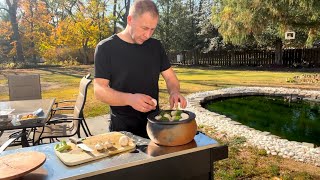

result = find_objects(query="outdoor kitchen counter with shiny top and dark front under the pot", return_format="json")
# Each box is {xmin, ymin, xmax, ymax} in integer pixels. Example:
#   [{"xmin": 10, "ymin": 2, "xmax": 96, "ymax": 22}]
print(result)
[{"xmin": 1, "ymin": 133, "xmax": 228, "ymax": 180}]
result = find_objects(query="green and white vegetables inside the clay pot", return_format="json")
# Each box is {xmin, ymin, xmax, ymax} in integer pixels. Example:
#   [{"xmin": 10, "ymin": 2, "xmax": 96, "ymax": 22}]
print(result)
[{"xmin": 154, "ymin": 110, "xmax": 189, "ymax": 121}]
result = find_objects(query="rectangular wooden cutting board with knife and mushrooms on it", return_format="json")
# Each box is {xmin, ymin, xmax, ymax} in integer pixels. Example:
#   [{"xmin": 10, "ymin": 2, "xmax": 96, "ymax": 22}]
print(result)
[{"xmin": 55, "ymin": 132, "xmax": 136, "ymax": 166}]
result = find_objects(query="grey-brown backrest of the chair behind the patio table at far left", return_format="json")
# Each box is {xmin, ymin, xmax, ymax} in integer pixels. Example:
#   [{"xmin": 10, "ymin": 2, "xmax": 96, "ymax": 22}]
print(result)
[{"xmin": 7, "ymin": 74, "xmax": 42, "ymax": 101}]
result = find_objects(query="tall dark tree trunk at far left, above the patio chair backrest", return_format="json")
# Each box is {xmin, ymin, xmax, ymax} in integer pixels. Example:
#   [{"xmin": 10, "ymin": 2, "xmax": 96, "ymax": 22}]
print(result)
[{"xmin": 6, "ymin": 0, "xmax": 25, "ymax": 62}]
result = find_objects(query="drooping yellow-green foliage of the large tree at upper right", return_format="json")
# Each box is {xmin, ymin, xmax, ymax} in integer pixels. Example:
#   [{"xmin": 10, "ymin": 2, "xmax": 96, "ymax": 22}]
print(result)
[{"xmin": 212, "ymin": 0, "xmax": 320, "ymax": 46}]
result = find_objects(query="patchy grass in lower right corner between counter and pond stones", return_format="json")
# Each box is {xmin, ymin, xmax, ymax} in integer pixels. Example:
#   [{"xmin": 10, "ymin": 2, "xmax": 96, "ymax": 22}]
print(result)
[{"xmin": 198, "ymin": 126, "xmax": 320, "ymax": 180}]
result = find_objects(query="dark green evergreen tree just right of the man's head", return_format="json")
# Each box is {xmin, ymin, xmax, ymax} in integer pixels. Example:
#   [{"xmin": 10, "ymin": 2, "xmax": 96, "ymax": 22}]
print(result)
[{"xmin": 155, "ymin": 0, "xmax": 198, "ymax": 51}]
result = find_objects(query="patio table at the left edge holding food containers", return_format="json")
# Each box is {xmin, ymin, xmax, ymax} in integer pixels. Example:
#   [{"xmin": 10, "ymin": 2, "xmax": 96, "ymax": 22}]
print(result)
[{"xmin": 0, "ymin": 98, "xmax": 55, "ymax": 147}]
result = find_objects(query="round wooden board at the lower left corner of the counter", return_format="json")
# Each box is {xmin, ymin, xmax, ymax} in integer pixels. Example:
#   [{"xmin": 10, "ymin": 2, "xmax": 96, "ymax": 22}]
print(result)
[{"xmin": 0, "ymin": 151, "xmax": 46, "ymax": 179}]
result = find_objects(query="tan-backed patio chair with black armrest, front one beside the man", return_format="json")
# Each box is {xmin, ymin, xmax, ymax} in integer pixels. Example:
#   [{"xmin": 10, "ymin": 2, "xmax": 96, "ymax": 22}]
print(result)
[{"xmin": 33, "ymin": 77, "xmax": 92, "ymax": 145}]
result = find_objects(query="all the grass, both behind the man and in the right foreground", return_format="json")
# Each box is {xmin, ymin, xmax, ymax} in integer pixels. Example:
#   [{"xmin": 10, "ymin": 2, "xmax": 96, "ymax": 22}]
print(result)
[{"xmin": 0, "ymin": 65, "xmax": 320, "ymax": 179}]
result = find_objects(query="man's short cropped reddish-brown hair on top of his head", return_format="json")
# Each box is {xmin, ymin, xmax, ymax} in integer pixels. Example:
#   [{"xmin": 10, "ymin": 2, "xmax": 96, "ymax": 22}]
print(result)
[{"xmin": 129, "ymin": 0, "xmax": 159, "ymax": 17}]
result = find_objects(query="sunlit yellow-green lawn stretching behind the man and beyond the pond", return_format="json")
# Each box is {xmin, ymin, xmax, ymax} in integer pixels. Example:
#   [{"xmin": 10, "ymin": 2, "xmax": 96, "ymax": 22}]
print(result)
[{"xmin": 0, "ymin": 65, "xmax": 320, "ymax": 117}]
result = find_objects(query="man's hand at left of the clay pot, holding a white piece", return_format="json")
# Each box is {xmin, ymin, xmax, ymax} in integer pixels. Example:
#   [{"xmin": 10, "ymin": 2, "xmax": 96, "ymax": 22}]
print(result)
[{"xmin": 128, "ymin": 94, "xmax": 156, "ymax": 112}]
